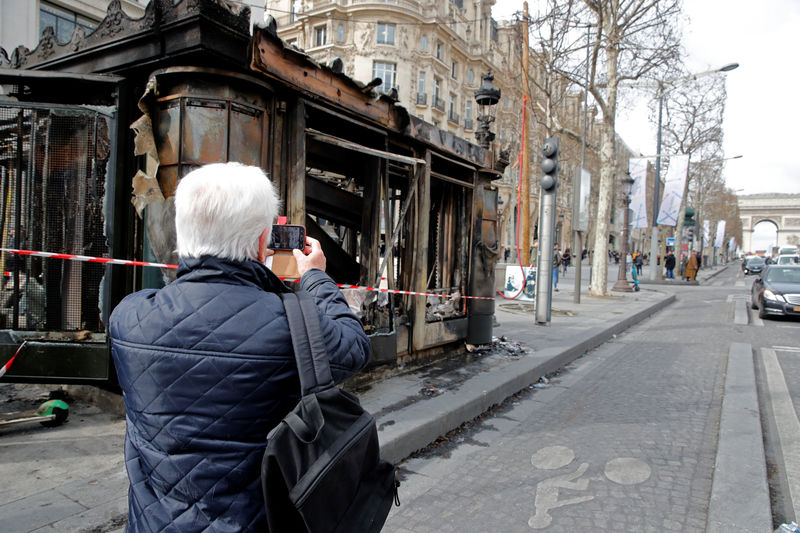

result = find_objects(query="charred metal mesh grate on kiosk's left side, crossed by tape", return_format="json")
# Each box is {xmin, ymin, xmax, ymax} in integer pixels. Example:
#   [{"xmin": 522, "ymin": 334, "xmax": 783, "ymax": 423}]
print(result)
[{"xmin": 0, "ymin": 105, "xmax": 110, "ymax": 332}]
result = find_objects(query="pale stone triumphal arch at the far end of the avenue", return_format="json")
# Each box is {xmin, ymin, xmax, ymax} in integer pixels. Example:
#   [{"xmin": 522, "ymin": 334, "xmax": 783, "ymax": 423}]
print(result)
[{"xmin": 738, "ymin": 193, "xmax": 800, "ymax": 253}]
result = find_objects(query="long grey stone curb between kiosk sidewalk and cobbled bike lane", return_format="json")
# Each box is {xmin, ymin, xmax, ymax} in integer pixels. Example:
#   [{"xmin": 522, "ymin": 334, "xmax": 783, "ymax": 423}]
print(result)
[{"xmin": 378, "ymin": 294, "xmax": 675, "ymax": 463}]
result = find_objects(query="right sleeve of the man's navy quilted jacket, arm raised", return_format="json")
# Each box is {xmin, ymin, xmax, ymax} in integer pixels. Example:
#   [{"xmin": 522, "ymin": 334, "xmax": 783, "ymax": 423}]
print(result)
[{"xmin": 300, "ymin": 269, "xmax": 371, "ymax": 383}]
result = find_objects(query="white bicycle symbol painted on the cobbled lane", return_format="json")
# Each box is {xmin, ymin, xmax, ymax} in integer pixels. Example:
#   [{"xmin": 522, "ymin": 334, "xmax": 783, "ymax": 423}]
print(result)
[{"xmin": 528, "ymin": 446, "xmax": 651, "ymax": 529}]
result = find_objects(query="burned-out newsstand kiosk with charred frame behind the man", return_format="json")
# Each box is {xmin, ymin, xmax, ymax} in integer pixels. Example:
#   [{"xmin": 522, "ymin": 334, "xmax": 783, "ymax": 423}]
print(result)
[{"xmin": 0, "ymin": 0, "xmax": 502, "ymax": 383}]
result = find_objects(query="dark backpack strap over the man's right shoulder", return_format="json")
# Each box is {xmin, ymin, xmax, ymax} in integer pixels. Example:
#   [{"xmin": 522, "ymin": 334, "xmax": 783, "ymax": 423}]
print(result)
[{"xmin": 280, "ymin": 291, "xmax": 334, "ymax": 396}]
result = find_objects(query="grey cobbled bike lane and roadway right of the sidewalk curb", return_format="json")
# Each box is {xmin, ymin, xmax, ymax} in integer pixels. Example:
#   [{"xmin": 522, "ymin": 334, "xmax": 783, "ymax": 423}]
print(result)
[{"xmin": 384, "ymin": 262, "xmax": 800, "ymax": 533}]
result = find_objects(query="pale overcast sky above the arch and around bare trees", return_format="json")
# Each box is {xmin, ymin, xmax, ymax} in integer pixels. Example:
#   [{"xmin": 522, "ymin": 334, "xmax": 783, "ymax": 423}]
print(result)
[{"xmin": 493, "ymin": 0, "xmax": 800, "ymax": 194}]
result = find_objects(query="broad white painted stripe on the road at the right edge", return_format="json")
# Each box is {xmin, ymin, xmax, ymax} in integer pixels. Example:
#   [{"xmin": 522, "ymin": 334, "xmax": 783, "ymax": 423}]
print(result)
[{"xmin": 761, "ymin": 348, "xmax": 800, "ymax": 516}]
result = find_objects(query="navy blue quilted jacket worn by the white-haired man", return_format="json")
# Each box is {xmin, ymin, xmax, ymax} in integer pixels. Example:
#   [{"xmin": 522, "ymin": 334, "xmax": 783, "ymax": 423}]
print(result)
[{"xmin": 109, "ymin": 257, "xmax": 370, "ymax": 533}]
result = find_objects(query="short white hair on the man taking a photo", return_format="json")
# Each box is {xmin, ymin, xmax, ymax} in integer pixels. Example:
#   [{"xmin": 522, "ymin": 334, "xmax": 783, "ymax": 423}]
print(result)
[{"xmin": 175, "ymin": 163, "xmax": 280, "ymax": 261}]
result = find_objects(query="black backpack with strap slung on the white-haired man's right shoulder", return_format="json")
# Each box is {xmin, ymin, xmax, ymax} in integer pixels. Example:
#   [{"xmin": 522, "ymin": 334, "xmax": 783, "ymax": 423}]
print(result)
[{"xmin": 261, "ymin": 292, "xmax": 399, "ymax": 533}]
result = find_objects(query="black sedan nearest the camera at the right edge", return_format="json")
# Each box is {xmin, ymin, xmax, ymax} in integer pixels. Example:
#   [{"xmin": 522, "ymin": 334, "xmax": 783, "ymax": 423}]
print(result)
[{"xmin": 750, "ymin": 265, "xmax": 800, "ymax": 318}]
